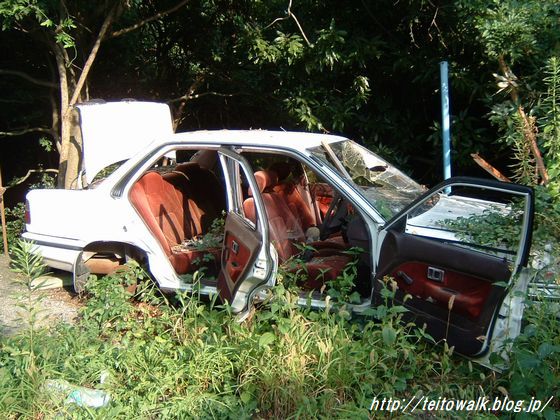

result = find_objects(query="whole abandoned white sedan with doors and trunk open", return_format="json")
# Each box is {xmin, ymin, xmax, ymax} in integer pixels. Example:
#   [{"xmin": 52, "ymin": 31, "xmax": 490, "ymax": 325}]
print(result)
[{"xmin": 24, "ymin": 102, "xmax": 533, "ymax": 359}]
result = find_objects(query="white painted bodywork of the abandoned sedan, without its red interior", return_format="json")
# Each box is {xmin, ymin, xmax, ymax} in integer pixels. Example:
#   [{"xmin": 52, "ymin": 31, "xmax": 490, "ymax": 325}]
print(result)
[{"xmin": 24, "ymin": 102, "xmax": 532, "ymax": 360}]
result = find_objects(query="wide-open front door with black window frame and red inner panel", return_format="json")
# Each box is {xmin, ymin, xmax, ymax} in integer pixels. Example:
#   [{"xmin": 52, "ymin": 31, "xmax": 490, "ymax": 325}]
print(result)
[{"xmin": 373, "ymin": 177, "xmax": 534, "ymax": 357}]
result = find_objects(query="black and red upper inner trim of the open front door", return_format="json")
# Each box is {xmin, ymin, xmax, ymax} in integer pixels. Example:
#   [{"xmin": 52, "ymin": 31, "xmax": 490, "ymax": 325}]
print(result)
[{"xmin": 377, "ymin": 232, "xmax": 511, "ymax": 322}]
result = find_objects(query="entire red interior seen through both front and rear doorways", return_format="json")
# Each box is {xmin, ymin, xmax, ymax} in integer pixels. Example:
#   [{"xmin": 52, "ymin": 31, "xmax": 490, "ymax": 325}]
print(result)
[{"xmin": 129, "ymin": 150, "xmax": 371, "ymax": 299}]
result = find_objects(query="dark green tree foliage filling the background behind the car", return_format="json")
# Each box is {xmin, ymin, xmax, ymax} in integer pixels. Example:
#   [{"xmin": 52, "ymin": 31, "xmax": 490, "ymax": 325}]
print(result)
[{"xmin": 0, "ymin": 0, "xmax": 560, "ymax": 187}]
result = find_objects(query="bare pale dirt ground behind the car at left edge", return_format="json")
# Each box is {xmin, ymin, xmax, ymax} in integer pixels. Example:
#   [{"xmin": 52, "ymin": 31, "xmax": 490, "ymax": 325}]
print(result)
[{"xmin": 0, "ymin": 254, "xmax": 82, "ymax": 335}]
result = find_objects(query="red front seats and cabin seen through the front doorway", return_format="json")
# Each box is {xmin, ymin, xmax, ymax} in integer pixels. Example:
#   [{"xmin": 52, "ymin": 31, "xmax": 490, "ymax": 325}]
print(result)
[{"xmin": 244, "ymin": 152, "xmax": 371, "ymax": 298}]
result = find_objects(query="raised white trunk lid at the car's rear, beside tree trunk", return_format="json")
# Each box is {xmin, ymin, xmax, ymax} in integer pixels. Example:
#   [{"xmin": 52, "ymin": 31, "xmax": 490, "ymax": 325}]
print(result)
[{"xmin": 76, "ymin": 101, "xmax": 173, "ymax": 184}]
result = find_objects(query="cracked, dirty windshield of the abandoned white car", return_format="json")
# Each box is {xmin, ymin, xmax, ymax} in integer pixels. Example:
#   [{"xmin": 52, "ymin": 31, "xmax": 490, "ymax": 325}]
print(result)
[{"xmin": 309, "ymin": 140, "xmax": 424, "ymax": 220}]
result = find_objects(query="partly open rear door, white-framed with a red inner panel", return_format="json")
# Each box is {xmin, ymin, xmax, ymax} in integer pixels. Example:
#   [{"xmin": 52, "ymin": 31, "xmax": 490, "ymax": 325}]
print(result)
[{"xmin": 218, "ymin": 149, "xmax": 277, "ymax": 313}]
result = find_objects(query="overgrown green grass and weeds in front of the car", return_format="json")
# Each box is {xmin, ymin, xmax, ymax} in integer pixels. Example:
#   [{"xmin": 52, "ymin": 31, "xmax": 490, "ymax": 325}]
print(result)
[{"xmin": 0, "ymin": 246, "xmax": 560, "ymax": 419}]
